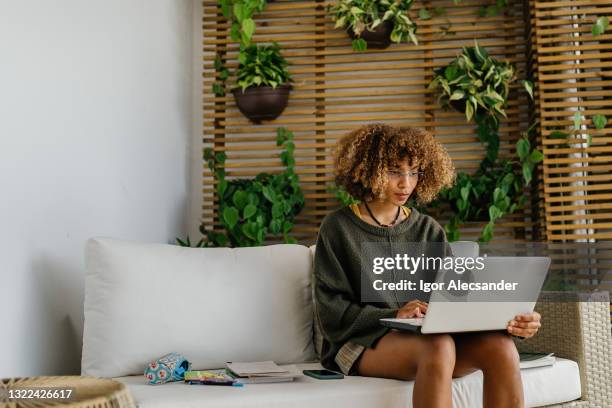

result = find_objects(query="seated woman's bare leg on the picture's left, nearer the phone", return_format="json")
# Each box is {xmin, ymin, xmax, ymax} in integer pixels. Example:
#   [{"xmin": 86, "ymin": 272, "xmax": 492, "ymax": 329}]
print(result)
[{"xmin": 357, "ymin": 331, "xmax": 455, "ymax": 408}]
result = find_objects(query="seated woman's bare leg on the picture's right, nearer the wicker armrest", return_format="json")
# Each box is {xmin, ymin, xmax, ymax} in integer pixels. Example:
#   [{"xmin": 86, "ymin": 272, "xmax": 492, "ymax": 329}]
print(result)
[{"xmin": 452, "ymin": 332, "xmax": 525, "ymax": 408}]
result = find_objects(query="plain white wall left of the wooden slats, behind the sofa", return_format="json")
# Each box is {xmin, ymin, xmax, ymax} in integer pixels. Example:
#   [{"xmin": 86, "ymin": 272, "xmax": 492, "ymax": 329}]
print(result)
[{"xmin": 0, "ymin": 0, "xmax": 194, "ymax": 377}]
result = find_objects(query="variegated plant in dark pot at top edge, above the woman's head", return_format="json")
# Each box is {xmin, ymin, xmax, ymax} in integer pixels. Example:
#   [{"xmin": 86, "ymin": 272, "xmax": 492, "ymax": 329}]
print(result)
[{"xmin": 328, "ymin": 0, "xmax": 418, "ymax": 51}]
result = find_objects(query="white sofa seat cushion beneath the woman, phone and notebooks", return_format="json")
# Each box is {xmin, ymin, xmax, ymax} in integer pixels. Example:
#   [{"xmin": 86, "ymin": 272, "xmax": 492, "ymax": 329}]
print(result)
[{"xmin": 118, "ymin": 358, "xmax": 580, "ymax": 408}]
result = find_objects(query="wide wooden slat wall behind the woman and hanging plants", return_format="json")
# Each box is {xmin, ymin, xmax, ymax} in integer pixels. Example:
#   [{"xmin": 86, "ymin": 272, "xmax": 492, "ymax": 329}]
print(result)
[{"xmin": 202, "ymin": 0, "xmax": 538, "ymax": 244}]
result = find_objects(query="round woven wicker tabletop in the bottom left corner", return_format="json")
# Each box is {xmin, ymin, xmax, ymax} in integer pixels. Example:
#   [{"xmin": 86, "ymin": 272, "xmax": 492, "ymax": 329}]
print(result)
[{"xmin": 0, "ymin": 376, "xmax": 136, "ymax": 408}]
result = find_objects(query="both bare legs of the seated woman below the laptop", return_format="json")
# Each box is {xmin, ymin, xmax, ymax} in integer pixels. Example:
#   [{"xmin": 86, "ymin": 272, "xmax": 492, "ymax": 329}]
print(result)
[{"xmin": 357, "ymin": 331, "xmax": 524, "ymax": 408}]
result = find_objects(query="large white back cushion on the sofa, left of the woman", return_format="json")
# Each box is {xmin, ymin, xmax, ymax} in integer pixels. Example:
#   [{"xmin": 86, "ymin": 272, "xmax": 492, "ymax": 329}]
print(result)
[{"xmin": 81, "ymin": 239, "xmax": 315, "ymax": 377}]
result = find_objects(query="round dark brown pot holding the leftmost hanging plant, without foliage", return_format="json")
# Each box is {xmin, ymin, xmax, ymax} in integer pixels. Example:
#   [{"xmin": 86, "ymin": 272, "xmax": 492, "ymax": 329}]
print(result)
[{"xmin": 232, "ymin": 84, "xmax": 291, "ymax": 123}]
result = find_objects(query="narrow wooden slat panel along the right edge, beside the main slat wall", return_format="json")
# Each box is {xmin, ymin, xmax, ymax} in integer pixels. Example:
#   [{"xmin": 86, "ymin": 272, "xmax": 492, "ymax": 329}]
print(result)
[{"xmin": 530, "ymin": 0, "xmax": 612, "ymax": 241}]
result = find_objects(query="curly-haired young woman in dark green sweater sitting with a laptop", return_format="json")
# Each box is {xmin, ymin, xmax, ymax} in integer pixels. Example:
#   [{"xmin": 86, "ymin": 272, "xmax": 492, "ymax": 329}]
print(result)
[{"xmin": 314, "ymin": 124, "xmax": 540, "ymax": 408}]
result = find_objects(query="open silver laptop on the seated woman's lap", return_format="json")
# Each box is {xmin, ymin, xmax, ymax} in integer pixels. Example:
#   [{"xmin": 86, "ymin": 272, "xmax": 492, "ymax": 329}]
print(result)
[{"xmin": 380, "ymin": 257, "xmax": 550, "ymax": 334}]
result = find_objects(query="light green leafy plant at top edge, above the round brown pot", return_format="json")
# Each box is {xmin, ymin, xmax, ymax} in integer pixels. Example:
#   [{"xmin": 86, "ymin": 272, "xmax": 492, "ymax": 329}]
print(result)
[{"xmin": 218, "ymin": 0, "xmax": 266, "ymax": 47}]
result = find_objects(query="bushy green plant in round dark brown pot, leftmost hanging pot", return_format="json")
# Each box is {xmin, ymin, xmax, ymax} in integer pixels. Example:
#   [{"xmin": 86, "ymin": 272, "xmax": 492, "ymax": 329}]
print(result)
[{"xmin": 232, "ymin": 43, "xmax": 292, "ymax": 123}]
